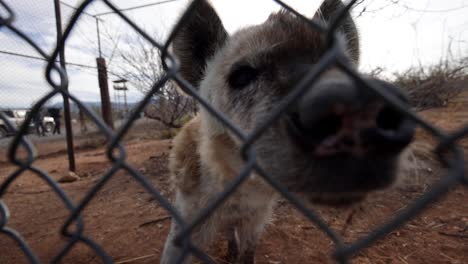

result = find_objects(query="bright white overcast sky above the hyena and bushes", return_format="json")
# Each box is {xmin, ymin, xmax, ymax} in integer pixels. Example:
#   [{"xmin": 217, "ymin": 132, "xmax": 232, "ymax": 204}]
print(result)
[{"xmin": 0, "ymin": 0, "xmax": 468, "ymax": 107}]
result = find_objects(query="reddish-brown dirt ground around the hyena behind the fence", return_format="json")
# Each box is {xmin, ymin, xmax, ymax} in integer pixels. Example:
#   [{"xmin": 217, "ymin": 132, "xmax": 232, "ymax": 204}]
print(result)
[{"xmin": 0, "ymin": 100, "xmax": 468, "ymax": 264}]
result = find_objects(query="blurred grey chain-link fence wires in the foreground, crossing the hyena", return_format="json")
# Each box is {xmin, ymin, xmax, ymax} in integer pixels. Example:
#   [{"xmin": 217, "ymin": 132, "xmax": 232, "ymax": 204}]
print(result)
[{"xmin": 0, "ymin": 0, "xmax": 468, "ymax": 263}]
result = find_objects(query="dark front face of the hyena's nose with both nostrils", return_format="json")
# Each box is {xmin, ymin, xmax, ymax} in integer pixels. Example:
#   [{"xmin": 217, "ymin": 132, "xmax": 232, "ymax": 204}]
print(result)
[{"xmin": 290, "ymin": 98, "xmax": 415, "ymax": 157}]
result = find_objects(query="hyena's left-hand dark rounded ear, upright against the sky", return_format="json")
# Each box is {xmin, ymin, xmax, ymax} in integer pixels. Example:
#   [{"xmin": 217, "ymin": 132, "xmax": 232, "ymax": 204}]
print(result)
[{"xmin": 173, "ymin": 0, "xmax": 228, "ymax": 88}]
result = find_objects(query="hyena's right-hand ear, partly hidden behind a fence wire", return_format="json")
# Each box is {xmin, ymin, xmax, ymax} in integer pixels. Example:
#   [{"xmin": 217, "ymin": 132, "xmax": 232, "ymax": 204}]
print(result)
[{"xmin": 314, "ymin": 0, "xmax": 360, "ymax": 64}]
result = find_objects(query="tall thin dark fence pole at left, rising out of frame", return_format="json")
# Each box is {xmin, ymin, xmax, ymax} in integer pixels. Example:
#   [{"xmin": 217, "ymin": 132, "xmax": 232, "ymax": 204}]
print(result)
[{"xmin": 54, "ymin": 0, "xmax": 76, "ymax": 172}]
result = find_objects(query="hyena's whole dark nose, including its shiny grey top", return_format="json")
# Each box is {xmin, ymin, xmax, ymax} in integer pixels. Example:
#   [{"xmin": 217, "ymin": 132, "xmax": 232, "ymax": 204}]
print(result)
[{"xmin": 288, "ymin": 80, "xmax": 415, "ymax": 157}]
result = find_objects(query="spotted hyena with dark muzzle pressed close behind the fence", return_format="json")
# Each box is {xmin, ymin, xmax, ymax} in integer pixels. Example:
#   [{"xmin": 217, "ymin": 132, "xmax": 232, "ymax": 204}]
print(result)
[{"xmin": 161, "ymin": 0, "xmax": 414, "ymax": 264}]
